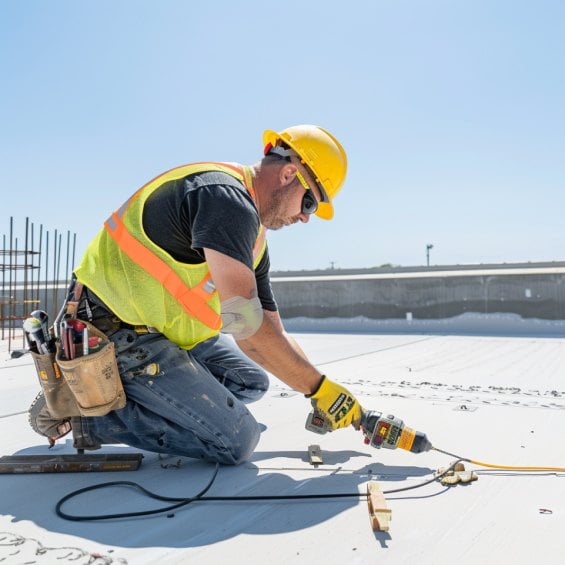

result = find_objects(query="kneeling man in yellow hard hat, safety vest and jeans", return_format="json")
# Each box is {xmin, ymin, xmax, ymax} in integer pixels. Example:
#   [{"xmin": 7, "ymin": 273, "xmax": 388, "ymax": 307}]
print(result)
[{"xmin": 30, "ymin": 125, "xmax": 361, "ymax": 464}]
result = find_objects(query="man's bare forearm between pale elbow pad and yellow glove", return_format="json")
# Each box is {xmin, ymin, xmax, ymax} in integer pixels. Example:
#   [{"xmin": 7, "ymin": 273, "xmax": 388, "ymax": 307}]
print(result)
[{"xmin": 237, "ymin": 316, "xmax": 322, "ymax": 394}]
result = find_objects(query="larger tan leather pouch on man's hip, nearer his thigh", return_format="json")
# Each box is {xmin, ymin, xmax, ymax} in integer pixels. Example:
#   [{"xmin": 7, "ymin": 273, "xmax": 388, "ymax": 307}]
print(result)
[{"xmin": 56, "ymin": 320, "xmax": 126, "ymax": 416}]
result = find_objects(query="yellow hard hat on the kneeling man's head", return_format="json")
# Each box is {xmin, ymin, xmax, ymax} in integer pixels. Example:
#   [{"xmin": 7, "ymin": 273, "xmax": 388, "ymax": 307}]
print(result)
[{"xmin": 263, "ymin": 125, "xmax": 347, "ymax": 220}]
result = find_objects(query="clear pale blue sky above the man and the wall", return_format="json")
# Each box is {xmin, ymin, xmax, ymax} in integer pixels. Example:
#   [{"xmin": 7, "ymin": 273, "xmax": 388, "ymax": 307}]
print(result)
[{"xmin": 0, "ymin": 0, "xmax": 565, "ymax": 269}]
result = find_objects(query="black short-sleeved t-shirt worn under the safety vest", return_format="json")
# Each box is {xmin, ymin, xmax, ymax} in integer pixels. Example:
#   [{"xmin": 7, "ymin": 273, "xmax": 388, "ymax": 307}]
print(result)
[{"xmin": 143, "ymin": 171, "xmax": 277, "ymax": 311}]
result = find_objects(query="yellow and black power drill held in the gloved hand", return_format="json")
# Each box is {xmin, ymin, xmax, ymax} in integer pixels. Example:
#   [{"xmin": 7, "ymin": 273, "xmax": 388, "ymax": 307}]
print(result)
[{"xmin": 306, "ymin": 410, "xmax": 432, "ymax": 453}]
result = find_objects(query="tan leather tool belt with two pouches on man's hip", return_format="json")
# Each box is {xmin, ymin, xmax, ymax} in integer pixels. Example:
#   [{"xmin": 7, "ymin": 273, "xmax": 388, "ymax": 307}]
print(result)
[{"xmin": 32, "ymin": 281, "xmax": 126, "ymax": 418}]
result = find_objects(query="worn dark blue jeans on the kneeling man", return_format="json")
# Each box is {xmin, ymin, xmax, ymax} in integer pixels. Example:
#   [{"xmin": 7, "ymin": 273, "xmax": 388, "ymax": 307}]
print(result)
[{"xmin": 81, "ymin": 329, "xmax": 269, "ymax": 465}]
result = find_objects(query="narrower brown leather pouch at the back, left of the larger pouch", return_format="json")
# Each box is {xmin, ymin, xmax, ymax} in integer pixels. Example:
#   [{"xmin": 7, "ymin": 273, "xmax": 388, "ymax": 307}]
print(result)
[{"xmin": 31, "ymin": 351, "xmax": 80, "ymax": 418}]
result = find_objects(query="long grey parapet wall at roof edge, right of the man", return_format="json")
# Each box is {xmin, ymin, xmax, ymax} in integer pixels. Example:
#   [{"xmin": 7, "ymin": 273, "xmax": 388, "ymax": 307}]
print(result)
[{"xmin": 272, "ymin": 267, "xmax": 565, "ymax": 320}]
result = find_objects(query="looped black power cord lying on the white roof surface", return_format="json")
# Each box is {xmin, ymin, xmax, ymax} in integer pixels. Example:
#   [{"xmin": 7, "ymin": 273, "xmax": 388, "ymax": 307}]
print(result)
[{"xmin": 55, "ymin": 459, "xmax": 463, "ymax": 522}]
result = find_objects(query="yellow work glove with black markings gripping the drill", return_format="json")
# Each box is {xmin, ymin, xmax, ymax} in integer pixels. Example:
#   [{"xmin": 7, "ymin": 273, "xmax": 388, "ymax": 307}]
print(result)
[{"xmin": 306, "ymin": 376, "xmax": 361, "ymax": 430}]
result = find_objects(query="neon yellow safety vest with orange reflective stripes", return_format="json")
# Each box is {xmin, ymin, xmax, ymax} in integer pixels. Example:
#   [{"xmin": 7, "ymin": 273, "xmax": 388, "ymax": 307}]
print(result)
[{"xmin": 76, "ymin": 163, "xmax": 267, "ymax": 349}]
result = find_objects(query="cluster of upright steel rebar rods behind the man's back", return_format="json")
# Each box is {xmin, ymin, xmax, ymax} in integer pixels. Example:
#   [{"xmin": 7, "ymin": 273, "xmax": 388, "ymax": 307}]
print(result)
[{"xmin": 0, "ymin": 217, "xmax": 76, "ymax": 351}]
